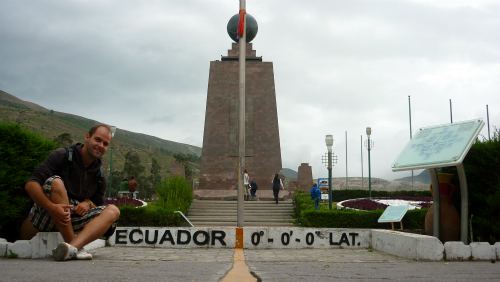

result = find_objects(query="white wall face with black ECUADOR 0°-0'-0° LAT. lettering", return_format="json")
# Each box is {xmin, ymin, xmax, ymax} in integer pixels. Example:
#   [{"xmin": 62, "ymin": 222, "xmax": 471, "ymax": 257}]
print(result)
[{"xmin": 113, "ymin": 227, "xmax": 371, "ymax": 249}]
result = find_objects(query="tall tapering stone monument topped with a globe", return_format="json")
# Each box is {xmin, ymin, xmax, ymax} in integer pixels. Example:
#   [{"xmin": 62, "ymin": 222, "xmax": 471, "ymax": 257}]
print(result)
[{"xmin": 199, "ymin": 14, "xmax": 281, "ymax": 190}]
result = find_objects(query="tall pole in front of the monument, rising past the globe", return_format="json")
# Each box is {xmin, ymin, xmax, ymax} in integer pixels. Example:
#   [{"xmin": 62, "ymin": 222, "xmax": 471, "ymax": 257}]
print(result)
[{"xmin": 237, "ymin": 0, "xmax": 246, "ymax": 227}]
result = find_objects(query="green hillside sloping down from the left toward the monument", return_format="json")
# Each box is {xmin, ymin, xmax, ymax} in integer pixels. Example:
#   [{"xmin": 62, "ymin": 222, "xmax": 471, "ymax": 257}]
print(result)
[{"xmin": 0, "ymin": 90, "xmax": 201, "ymax": 185}]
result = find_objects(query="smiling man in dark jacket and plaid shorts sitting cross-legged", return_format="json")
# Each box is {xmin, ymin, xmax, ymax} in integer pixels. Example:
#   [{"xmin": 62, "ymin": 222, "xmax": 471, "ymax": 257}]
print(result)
[{"xmin": 21, "ymin": 124, "xmax": 120, "ymax": 261}]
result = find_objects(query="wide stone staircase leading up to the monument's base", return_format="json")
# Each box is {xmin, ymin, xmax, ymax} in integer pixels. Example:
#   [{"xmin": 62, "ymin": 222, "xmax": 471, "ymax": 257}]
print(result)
[{"xmin": 187, "ymin": 199, "xmax": 294, "ymax": 227}]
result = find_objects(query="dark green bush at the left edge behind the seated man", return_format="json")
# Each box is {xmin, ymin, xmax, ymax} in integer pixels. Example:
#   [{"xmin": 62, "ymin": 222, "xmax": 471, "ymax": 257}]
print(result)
[{"xmin": 0, "ymin": 123, "xmax": 56, "ymax": 241}]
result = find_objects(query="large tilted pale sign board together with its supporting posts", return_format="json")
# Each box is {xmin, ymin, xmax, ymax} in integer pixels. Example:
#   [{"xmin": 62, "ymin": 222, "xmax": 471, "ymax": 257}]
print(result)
[{"xmin": 392, "ymin": 119, "xmax": 484, "ymax": 244}]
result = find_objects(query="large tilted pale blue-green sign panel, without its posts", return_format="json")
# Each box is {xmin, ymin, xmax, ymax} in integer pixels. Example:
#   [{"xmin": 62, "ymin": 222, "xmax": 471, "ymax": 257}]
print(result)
[{"xmin": 392, "ymin": 119, "xmax": 484, "ymax": 171}]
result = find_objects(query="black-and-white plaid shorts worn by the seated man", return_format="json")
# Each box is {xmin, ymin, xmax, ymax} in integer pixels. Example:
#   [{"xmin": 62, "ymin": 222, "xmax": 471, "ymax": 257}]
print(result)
[{"xmin": 30, "ymin": 175, "xmax": 106, "ymax": 232}]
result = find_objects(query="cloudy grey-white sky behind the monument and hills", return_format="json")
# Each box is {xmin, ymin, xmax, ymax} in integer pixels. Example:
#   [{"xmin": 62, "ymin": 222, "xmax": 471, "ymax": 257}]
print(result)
[{"xmin": 0, "ymin": 0, "xmax": 500, "ymax": 179}]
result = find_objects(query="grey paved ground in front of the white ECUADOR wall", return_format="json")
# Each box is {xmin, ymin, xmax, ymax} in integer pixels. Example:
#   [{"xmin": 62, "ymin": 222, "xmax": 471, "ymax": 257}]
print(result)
[{"xmin": 0, "ymin": 247, "xmax": 500, "ymax": 281}]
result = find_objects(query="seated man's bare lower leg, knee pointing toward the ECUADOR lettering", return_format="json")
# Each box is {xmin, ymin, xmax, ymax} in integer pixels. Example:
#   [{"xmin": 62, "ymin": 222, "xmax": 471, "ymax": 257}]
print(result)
[{"xmin": 68, "ymin": 205, "xmax": 120, "ymax": 249}]
